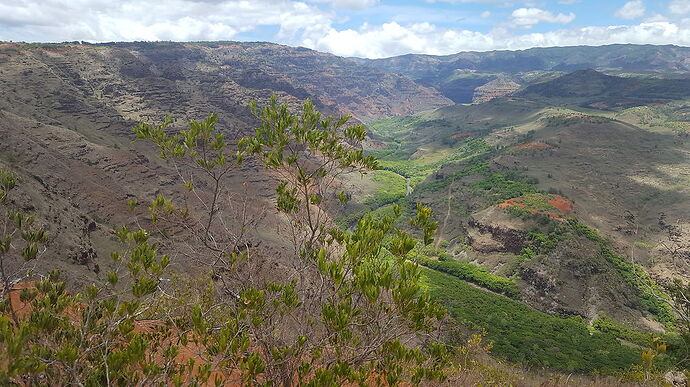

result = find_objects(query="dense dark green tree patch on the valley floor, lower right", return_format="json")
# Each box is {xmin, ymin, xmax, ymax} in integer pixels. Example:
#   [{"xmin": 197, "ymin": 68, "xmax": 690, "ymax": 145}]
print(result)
[{"xmin": 424, "ymin": 269, "xmax": 641, "ymax": 372}]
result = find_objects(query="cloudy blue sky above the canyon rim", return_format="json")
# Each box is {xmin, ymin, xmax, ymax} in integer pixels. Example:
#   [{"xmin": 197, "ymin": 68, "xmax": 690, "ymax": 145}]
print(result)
[{"xmin": 0, "ymin": 0, "xmax": 690, "ymax": 58}]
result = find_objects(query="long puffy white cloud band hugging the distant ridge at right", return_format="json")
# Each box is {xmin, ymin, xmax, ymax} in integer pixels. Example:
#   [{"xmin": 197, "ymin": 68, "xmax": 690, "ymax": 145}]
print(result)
[{"xmin": 303, "ymin": 22, "xmax": 690, "ymax": 58}]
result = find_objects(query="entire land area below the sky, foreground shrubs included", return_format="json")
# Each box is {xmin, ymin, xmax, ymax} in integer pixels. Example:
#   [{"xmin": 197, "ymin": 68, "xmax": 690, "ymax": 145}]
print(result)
[{"xmin": 0, "ymin": 42, "xmax": 690, "ymax": 386}]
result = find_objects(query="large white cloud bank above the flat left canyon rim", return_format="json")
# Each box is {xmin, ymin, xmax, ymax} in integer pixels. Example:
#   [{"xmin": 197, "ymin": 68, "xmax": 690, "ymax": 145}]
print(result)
[{"xmin": 0, "ymin": 0, "xmax": 330, "ymax": 41}]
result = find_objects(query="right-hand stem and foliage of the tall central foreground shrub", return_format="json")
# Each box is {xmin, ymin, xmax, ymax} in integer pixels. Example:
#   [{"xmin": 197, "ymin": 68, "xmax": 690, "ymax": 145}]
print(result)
[{"xmin": 239, "ymin": 98, "xmax": 447, "ymax": 385}]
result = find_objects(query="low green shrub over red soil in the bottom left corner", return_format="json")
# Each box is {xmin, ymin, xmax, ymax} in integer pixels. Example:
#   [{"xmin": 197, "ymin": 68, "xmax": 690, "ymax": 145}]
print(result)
[{"xmin": 0, "ymin": 236, "xmax": 227, "ymax": 386}]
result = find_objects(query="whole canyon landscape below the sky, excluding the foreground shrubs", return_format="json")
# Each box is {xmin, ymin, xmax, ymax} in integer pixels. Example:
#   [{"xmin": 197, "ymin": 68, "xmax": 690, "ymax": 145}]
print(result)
[{"xmin": 0, "ymin": 42, "xmax": 690, "ymax": 378}]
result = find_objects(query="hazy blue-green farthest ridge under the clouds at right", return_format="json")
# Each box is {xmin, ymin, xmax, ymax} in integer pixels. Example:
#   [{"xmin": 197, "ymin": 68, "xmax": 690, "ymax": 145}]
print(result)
[{"xmin": 359, "ymin": 44, "xmax": 690, "ymax": 103}]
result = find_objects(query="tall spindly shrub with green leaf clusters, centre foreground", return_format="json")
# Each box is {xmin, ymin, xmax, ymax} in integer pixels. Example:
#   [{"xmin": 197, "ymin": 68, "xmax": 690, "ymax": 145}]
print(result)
[{"xmin": 135, "ymin": 97, "xmax": 447, "ymax": 385}]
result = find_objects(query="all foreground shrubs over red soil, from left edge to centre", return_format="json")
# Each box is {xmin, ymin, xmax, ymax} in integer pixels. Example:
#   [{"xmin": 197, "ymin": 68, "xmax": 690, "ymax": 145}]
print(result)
[{"xmin": 0, "ymin": 97, "xmax": 449, "ymax": 386}]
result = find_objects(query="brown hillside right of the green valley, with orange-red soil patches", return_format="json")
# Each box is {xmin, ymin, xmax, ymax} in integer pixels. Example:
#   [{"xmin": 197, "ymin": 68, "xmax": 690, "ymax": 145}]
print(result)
[{"xmin": 360, "ymin": 78, "xmax": 690, "ymax": 329}]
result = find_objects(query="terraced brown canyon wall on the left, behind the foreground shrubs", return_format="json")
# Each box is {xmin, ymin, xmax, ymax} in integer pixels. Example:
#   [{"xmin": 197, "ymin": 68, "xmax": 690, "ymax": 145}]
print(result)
[{"xmin": 0, "ymin": 43, "xmax": 450, "ymax": 283}]
